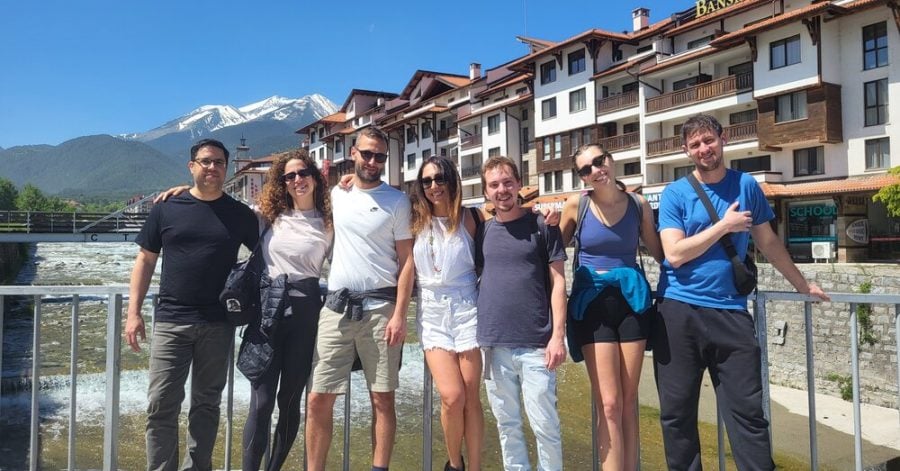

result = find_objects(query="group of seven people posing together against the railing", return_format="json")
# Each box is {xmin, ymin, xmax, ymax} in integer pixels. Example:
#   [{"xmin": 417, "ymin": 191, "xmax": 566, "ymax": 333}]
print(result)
[{"xmin": 125, "ymin": 115, "xmax": 828, "ymax": 471}]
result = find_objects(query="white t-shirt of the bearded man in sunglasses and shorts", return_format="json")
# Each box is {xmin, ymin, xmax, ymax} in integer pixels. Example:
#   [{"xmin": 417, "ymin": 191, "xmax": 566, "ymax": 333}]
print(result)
[{"xmin": 328, "ymin": 183, "xmax": 413, "ymax": 296}]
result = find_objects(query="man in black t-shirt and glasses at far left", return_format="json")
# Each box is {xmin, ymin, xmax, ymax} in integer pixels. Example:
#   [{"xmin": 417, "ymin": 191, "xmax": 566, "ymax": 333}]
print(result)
[{"xmin": 125, "ymin": 139, "xmax": 259, "ymax": 471}]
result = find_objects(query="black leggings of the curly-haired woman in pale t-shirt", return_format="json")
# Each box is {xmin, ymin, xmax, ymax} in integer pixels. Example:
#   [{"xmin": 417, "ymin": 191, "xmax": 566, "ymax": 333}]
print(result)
[{"xmin": 242, "ymin": 296, "xmax": 322, "ymax": 471}]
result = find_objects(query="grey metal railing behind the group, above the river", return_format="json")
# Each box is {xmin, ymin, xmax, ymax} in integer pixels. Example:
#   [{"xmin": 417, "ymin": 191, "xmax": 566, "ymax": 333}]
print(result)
[{"xmin": 0, "ymin": 286, "xmax": 900, "ymax": 471}]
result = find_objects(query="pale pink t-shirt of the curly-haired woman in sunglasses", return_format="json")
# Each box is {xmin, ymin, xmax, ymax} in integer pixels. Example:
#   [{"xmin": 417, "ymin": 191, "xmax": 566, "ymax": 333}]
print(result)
[{"xmin": 260, "ymin": 209, "xmax": 333, "ymax": 281}]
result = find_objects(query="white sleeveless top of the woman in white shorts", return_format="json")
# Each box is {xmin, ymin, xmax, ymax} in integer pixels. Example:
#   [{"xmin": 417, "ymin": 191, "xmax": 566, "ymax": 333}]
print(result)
[{"xmin": 413, "ymin": 213, "xmax": 477, "ymax": 287}]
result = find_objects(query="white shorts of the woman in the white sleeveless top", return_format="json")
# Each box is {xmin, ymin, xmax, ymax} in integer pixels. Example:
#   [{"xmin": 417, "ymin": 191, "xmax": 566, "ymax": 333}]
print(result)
[{"xmin": 416, "ymin": 285, "xmax": 478, "ymax": 353}]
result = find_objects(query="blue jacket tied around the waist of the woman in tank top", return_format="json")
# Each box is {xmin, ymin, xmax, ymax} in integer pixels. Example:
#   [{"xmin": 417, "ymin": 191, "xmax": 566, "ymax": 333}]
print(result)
[{"xmin": 566, "ymin": 265, "xmax": 653, "ymax": 362}]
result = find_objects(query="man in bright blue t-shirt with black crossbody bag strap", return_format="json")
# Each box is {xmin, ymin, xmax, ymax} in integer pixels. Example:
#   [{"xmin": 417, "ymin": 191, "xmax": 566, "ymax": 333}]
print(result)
[{"xmin": 653, "ymin": 115, "xmax": 828, "ymax": 470}]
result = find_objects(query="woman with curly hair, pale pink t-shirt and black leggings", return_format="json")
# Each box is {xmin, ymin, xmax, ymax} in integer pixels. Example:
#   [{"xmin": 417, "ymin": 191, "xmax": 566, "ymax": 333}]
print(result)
[{"xmin": 160, "ymin": 150, "xmax": 334, "ymax": 471}]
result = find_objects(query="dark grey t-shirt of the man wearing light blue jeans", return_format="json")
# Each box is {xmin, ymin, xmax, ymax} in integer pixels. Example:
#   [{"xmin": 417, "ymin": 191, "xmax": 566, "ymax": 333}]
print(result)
[{"xmin": 477, "ymin": 212, "xmax": 566, "ymax": 348}]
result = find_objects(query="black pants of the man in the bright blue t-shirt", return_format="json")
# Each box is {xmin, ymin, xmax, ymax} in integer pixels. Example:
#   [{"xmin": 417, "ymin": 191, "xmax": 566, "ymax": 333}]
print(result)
[{"xmin": 653, "ymin": 299, "xmax": 775, "ymax": 471}]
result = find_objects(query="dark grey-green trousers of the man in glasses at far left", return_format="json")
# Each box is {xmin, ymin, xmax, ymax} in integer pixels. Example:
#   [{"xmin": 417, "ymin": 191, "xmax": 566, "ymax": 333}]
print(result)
[{"xmin": 147, "ymin": 322, "xmax": 234, "ymax": 471}]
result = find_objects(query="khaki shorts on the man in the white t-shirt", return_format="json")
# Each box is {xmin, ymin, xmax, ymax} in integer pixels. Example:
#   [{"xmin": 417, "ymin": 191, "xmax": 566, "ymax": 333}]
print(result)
[{"xmin": 309, "ymin": 303, "xmax": 403, "ymax": 394}]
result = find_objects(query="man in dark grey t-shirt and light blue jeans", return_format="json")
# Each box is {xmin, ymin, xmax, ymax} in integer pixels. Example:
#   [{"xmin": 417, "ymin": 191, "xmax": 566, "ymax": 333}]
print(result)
[{"xmin": 477, "ymin": 157, "xmax": 566, "ymax": 470}]
